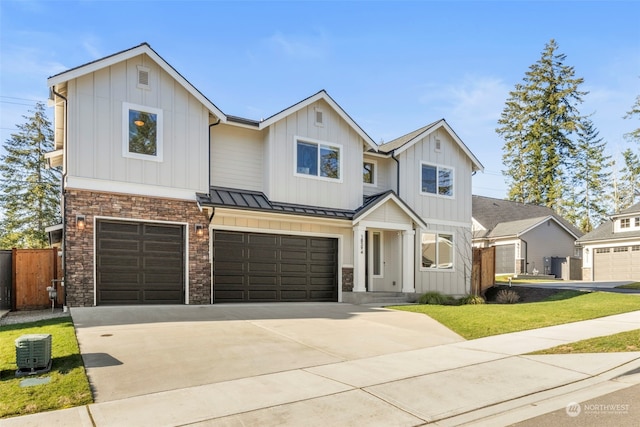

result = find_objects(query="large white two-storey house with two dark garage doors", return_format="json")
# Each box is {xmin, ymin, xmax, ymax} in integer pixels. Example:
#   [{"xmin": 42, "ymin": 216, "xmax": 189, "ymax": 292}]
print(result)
[{"xmin": 48, "ymin": 43, "xmax": 482, "ymax": 306}]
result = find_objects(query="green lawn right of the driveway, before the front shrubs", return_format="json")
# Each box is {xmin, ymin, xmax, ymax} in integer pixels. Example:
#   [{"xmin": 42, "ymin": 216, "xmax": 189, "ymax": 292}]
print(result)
[{"xmin": 388, "ymin": 291, "xmax": 640, "ymax": 339}]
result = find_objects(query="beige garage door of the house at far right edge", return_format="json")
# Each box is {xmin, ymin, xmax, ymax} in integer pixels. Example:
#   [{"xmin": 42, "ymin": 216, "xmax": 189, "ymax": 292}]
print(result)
[{"xmin": 593, "ymin": 245, "xmax": 640, "ymax": 281}]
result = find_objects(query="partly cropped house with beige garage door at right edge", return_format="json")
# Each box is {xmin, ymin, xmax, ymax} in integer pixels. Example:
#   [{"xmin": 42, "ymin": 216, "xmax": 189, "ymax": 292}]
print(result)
[{"xmin": 578, "ymin": 203, "xmax": 640, "ymax": 281}]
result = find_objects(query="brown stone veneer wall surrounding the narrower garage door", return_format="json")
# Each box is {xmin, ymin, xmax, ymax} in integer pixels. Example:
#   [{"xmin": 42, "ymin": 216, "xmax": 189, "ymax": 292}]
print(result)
[{"xmin": 64, "ymin": 190, "xmax": 211, "ymax": 307}]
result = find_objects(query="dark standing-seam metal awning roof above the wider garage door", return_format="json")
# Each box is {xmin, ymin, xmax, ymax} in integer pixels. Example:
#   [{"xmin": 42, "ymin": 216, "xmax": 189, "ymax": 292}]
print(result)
[{"xmin": 196, "ymin": 187, "xmax": 355, "ymax": 220}]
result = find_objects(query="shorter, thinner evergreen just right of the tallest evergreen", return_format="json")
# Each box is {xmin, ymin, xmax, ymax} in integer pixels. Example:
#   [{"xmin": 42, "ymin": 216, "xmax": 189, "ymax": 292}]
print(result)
[{"xmin": 570, "ymin": 118, "xmax": 613, "ymax": 233}]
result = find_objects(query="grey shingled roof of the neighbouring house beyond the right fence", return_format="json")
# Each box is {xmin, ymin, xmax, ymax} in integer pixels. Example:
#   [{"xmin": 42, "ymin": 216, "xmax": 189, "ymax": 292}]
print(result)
[{"xmin": 471, "ymin": 195, "xmax": 583, "ymax": 239}]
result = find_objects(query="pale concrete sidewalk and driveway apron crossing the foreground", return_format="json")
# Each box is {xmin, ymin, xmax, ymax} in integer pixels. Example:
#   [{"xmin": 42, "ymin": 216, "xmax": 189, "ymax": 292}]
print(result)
[{"xmin": 0, "ymin": 311, "xmax": 640, "ymax": 427}]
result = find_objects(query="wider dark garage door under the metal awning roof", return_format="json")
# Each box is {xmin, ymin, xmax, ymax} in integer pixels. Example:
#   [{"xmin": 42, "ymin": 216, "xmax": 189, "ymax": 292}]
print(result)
[{"xmin": 213, "ymin": 230, "xmax": 338, "ymax": 303}]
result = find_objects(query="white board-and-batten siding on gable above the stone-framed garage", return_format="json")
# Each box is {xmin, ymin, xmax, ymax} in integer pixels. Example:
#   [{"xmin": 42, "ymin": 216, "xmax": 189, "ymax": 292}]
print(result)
[{"xmin": 67, "ymin": 54, "xmax": 209, "ymax": 198}]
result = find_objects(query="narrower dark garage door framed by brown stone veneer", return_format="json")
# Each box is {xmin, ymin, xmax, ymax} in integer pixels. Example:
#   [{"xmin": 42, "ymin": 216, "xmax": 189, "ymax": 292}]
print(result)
[{"xmin": 96, "ymin": 220, "xmax": 185, "ymax": 305}]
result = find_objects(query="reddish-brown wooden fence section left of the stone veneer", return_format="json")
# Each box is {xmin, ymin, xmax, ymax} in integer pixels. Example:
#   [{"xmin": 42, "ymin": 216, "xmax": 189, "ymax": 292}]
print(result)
[{"xmin": 11, "ymin": 248, "xmax": 64, "ymax": 310}]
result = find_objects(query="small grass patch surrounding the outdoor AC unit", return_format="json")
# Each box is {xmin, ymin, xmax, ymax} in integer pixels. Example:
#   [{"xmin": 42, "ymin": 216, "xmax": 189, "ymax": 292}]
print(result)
[{"xmin": 0, "ymin": 317, "xmax": 93, "ymax": 418}]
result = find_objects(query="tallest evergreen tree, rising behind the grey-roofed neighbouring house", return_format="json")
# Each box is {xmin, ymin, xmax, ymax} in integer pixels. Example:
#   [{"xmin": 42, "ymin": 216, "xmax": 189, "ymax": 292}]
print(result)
[{"xmin": 496, "ymin": 39, "xmax": 587, "ymax": 210}]
